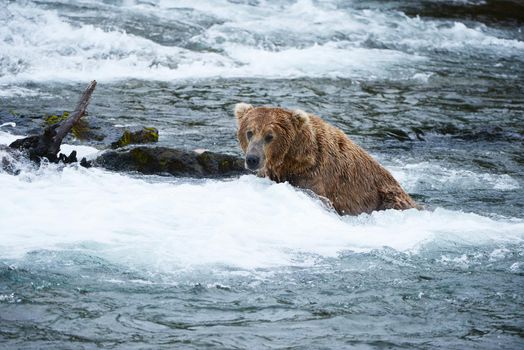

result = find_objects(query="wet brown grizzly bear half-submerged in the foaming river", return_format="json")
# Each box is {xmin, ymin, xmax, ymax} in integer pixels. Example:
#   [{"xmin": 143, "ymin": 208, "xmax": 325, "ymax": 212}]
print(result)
[{"xmin": 235, "ymin": 103, "xmax": 416, "ymax": 215}]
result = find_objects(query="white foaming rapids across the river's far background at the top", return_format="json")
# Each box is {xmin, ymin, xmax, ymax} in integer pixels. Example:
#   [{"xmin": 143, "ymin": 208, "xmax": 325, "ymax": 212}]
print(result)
[{"xmin": 0, "ymin": 0, "xmax": 524, "ymax": 83}]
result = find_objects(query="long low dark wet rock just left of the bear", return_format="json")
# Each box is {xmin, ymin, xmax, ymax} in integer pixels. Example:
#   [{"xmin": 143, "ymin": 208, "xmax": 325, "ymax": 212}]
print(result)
[{"xmin": 94, "ymin": 146, "xmax": 248, "ymax": 178}]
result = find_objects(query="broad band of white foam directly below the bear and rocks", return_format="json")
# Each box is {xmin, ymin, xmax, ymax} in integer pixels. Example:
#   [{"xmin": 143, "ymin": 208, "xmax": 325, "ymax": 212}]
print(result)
[{"xmin": 0, "ymin": 165, "xmax": 524, "ymax": 271}]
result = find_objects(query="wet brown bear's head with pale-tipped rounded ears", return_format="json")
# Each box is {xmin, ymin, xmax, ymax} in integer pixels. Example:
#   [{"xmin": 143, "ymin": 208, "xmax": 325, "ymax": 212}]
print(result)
[{"xmin": 235, "ymin": 103, "xmax": 316, "ymax": 178}]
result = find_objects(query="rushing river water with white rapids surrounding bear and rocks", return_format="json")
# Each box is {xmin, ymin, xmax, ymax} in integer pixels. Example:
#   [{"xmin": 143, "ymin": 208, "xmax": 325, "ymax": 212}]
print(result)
[{"xmin": 0, "ymin": 0, "xmax": 524, "ymax": 349}]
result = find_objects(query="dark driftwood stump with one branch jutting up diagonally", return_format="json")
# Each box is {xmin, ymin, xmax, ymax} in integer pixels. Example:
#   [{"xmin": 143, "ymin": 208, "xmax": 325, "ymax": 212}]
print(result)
[{"xmin": 9, "ymin": 80, "xmax": 96, "ymax": 162}]
